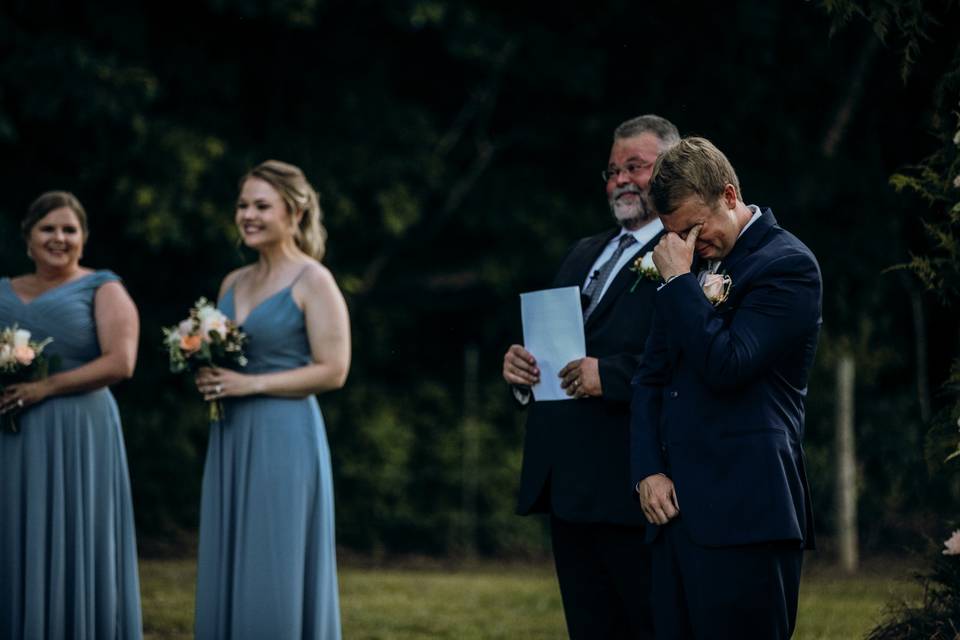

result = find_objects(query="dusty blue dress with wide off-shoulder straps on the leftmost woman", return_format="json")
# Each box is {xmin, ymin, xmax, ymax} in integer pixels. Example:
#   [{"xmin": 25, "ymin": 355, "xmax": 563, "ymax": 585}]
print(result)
[{"xmin": 0, "ymin": 271, "xmax": 142, "ymax": 640}]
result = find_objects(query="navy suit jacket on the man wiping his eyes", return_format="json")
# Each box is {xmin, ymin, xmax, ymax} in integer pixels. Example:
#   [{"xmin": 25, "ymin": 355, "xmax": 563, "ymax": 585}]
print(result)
[{"xmin": 630, "ymin": 209, "xmax": 822, "ymax": 548}]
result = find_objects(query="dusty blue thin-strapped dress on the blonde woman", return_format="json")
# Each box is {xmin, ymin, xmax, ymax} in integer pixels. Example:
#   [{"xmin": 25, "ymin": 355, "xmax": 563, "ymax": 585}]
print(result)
[{"xmin": 196, "ymin": 285, "xmax": 340, "ymax": 640}]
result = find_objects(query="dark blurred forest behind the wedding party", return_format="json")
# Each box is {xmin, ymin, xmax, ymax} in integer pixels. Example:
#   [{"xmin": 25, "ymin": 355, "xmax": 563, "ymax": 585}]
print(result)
[{"xmin": 0, "ymin": 0, "xmax": 960, "ymax": 557}]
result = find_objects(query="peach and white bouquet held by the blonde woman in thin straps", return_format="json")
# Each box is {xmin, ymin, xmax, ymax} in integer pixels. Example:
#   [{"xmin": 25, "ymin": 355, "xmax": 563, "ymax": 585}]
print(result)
[{"xmin": 163, "ymin": 298, "xmax": 247, "ymax": 420}]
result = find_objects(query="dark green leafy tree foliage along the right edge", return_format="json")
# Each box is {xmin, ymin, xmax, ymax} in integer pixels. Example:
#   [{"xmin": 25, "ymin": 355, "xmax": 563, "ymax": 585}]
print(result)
[{"xmin": 824, "ymin": 0, "xmax": 960, "ymax": 640}]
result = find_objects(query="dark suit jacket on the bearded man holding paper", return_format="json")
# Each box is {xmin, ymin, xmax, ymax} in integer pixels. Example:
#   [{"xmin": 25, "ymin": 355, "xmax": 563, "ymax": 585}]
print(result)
[{"xmin": 517, "ymin": 229, "xmax": 661, "ymax": 526}]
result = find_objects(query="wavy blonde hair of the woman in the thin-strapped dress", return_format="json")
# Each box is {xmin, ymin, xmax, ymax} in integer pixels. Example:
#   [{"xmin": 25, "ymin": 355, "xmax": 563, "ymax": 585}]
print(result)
[{"xmin": 240, "ymin": 160, "xmax": 327, "ymax": 260}]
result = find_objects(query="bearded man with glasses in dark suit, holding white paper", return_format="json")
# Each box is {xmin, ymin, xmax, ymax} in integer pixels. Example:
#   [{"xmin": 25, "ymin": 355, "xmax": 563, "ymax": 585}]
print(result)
[{"xmin": 503, "ymin": 115, "xmax": 679, "ymax": 640}]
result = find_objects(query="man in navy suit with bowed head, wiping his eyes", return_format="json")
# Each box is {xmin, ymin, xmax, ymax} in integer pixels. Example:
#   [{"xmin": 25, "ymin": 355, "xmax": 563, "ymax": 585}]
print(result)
[{"xmin": 630, "ymin": 138, "xmax": 821, "ymax": 640}]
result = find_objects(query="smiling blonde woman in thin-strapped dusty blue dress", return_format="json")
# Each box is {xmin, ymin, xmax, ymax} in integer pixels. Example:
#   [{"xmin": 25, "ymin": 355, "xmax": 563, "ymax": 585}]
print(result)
[{"xmin": 196, "ymin": 160, "xmax": 350, "ymax": 640}]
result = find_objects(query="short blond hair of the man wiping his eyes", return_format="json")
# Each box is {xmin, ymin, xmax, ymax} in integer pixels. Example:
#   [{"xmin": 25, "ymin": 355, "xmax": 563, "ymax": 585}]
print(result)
[{"xmin": 650, "ymin": 137, "xmax": 743, "ymax": 215}]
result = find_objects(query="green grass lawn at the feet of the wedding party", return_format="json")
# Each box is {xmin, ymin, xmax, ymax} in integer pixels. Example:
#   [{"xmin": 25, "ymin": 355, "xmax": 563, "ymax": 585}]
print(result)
[{"xmin": 140, "ymin": 560, "xmax": 920, "ymax": 640}]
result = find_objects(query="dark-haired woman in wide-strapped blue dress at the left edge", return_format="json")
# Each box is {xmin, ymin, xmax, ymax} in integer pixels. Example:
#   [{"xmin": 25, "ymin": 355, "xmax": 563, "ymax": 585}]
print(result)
[{"xmin": 0, "ymin": 191, "xmax": 142, "ymax": 640}]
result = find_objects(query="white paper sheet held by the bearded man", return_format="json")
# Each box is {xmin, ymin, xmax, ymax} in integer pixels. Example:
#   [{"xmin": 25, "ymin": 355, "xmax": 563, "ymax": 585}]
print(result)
[{"xmin": 520, "ymin": 287, "xmax": 587, "ymax": 400}]
